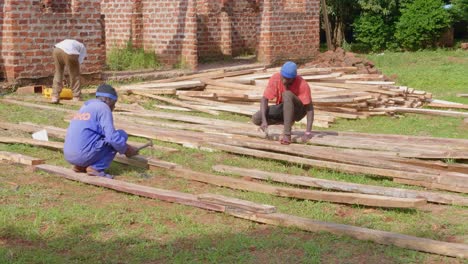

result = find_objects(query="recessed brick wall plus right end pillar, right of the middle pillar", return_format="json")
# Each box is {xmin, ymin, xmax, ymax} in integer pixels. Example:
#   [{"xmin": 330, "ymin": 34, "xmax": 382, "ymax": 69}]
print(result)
[{"xmin": 197, "ymin": 0, "xmax": 320, "ymax": 63}]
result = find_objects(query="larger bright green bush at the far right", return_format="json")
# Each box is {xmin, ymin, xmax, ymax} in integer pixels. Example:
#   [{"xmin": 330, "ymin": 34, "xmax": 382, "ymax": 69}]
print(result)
[{"xmin": 395, "ymin": 0, "xmax": 451, "ymax": 50}]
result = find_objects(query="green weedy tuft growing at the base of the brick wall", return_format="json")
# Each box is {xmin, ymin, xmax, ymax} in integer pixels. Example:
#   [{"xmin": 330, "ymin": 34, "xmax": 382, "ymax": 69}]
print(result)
[{"xmin": 107, "ymin": 42, "xmax": 160, "ymax": 71}]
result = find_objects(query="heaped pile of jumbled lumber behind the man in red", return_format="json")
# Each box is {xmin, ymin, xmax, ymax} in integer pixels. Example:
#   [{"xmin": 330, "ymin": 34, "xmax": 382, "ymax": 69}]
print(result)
[{"xmin": 118, "ymin": 67, "xmax": 432, "ymax": 127}]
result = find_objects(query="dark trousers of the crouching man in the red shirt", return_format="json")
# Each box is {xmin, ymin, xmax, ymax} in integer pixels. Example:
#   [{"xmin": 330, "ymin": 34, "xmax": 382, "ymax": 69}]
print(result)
[{"xmin": 252, "ymin": 91, "xmax": 307, "ymax": 135}]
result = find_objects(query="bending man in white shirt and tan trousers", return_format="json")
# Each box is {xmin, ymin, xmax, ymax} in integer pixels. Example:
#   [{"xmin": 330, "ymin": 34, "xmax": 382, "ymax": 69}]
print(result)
[{"xmin": 51, "ymin": 39, "xmax": 87, "ymax": 104}]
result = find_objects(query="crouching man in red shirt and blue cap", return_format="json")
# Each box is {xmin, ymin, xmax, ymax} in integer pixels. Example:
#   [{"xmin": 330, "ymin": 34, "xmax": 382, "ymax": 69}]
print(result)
[{"xmin": 252, "ymin": 61, "xmax": 314, "ymax": 145}]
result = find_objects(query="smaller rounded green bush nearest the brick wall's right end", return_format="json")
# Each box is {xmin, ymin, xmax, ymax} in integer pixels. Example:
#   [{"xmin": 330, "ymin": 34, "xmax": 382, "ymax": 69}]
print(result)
[{"xmin": 353, "ymin": 13, "xmax": 394, "ymax": 51}]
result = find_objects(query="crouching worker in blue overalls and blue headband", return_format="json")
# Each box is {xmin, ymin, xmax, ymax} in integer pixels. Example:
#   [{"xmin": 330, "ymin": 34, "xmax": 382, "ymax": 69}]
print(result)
[{"xmin": 63, "ymin": 84, "xmax": 138, "ymax": 179}]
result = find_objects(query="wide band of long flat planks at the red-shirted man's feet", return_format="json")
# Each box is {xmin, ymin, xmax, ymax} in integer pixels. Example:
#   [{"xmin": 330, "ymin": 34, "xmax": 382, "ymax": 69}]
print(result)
[{"xmin": 1, "ymin": 99, "xmax": 468, "ymax": 198}]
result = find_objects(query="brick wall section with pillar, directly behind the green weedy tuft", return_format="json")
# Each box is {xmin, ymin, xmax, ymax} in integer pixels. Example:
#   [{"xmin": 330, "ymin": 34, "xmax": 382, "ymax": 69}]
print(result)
[{"xmin": 102, "ymin": 0, "xmax": 198, "ymax": 67}]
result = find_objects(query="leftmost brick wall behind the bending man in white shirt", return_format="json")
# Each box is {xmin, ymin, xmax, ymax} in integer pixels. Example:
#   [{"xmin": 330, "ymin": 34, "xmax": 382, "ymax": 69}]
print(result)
[{"xmin": 1, "ymin": 0, "xmax": 105, "ymax": 81}]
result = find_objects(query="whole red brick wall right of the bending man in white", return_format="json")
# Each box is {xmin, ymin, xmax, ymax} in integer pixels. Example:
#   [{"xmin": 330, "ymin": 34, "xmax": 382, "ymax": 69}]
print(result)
[{"xmin": 101, "ymin": 0, "xmax": 319, "ymax": 68}]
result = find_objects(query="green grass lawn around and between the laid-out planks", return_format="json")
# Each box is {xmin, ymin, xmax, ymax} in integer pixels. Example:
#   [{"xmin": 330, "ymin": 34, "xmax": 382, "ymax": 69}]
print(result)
[{"xmin": 0, "ymin": 51, "xmax": 468, "ymax": 263}]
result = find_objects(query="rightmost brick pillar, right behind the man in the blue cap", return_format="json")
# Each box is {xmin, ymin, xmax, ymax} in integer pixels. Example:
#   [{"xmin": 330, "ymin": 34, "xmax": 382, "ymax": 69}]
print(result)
[{"xmin": 257, "ymin": 0, "xmax": 320, "ymax": 62}]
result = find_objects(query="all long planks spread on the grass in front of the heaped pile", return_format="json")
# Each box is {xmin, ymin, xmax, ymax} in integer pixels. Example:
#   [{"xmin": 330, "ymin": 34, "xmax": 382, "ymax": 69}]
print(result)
[{"xmin": 0, "ymin": 99, "xmax": 468, "ymax": 257}]
